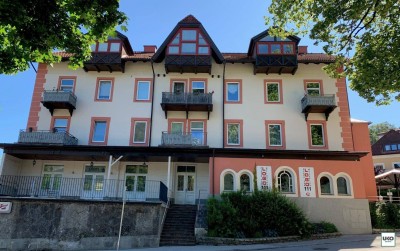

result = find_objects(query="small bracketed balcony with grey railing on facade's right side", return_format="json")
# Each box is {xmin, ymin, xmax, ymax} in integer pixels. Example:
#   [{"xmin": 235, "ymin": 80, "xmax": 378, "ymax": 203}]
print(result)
[{"xmin": 301, "ymin": 95, "xmax": 336, "ymax": 120}]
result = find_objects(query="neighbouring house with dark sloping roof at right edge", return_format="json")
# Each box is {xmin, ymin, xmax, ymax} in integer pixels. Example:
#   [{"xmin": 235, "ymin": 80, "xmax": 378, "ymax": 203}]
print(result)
[{"xmin": 371, "ymin": 129, "xmax": 400, "ymax": 175}]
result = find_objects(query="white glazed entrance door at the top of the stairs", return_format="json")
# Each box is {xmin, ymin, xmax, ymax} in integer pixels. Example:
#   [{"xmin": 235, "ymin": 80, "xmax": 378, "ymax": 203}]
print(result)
[{"xmin": 175, "ymin": 166, "xmax": 196, "ymax": 204}]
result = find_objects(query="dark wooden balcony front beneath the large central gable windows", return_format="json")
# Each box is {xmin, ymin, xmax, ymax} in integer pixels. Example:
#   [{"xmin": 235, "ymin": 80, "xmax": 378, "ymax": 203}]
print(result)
[{"xmin": 165, "ymin": 55, "xmax": 211, "ymax": 74}]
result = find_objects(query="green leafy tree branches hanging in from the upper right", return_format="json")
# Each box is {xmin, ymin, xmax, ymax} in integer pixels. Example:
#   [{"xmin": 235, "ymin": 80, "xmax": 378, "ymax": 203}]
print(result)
[{"xmin": 266, "ymin": 0, "xmax": 400, "ymax": 105}]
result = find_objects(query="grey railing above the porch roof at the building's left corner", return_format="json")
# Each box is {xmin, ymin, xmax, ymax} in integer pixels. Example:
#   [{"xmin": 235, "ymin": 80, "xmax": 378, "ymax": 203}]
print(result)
[{"xmin": 18, "ymin": 130, "xmax": 78, "ymax": 145}]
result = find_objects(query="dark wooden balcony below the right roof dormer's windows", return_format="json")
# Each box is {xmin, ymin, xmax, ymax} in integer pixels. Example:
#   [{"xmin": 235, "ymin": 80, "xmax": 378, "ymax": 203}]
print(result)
[{"xmin": 254, "ymin": 55, "xmax": 298, "ymax": 75}]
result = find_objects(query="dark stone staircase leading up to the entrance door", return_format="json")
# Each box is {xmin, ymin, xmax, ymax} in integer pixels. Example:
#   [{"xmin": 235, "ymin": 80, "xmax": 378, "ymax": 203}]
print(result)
[{"xmin": 160, "ymin": 205, "xmax": 197, "ymax": 246}]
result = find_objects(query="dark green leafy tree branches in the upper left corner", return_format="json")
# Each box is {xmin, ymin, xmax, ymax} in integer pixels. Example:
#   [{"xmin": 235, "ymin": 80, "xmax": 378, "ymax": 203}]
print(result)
[{"xmin": 0, "ymin": 0, "xmax": 127, "ymax": 74}]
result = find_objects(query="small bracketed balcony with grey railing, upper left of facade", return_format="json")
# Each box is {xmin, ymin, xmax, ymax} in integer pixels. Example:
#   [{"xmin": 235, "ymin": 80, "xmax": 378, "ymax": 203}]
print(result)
[{"xmin": 42, "ymin": 91, "xmax": 77, "ymax": 116}]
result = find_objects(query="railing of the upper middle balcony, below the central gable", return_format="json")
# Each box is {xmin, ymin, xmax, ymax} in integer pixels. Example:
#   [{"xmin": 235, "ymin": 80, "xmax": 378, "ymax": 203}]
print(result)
[{"xmin": 162, "ymin": 92, "xmax": 212, "ymax": 105}]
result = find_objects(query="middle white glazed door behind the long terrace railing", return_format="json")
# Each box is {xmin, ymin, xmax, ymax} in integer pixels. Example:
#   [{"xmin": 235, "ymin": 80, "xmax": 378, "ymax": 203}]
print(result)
[{"xmin": 82, "ymin": 166, "xmax": 106, "ymax": 199}]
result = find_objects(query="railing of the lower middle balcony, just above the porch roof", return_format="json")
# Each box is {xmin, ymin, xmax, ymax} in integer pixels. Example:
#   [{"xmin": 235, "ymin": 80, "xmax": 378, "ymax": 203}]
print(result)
[{"xmin": 161, "ymin": 132, "xmax": 207, "ymax": 147}]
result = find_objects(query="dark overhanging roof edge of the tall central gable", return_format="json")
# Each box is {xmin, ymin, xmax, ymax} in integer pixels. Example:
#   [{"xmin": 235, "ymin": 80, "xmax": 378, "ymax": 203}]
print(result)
[{"xmin": 153, "ymin": 15, "xmax": 224, "ymax": 64}]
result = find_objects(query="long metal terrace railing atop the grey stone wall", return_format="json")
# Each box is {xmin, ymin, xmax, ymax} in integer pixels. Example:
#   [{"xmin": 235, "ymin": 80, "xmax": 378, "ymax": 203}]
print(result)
[{"xmin": 0, "ymin": 175, "xmax": 168, "ymax": 203}]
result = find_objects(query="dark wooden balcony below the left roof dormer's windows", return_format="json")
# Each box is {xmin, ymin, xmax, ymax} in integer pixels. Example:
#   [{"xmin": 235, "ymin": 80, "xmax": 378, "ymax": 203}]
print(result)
[{"xmin": 83, "ymin": 52, "xmax": 125, "ymax": 72}]
